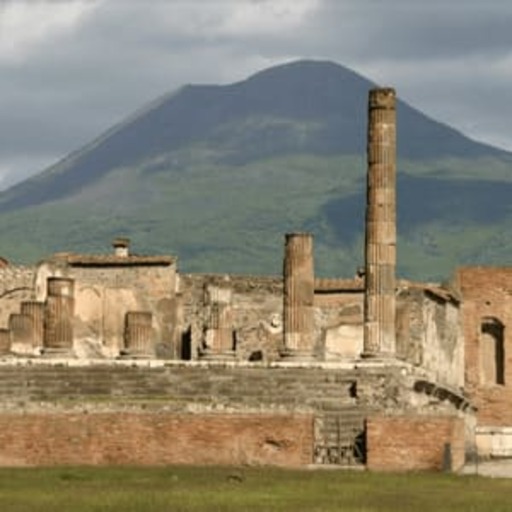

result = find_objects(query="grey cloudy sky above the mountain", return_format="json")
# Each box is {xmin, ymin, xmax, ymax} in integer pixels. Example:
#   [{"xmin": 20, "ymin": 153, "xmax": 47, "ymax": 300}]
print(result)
[{"xmin": 0, "ymin": 0, "xmax": 512, "ymax": 188}]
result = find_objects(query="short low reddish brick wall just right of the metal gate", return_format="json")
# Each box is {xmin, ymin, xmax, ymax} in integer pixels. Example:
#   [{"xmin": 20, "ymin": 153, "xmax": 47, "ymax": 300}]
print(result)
[{"xmin": 366, "ymin": 416, "xmax": 464, "ymax": 471}]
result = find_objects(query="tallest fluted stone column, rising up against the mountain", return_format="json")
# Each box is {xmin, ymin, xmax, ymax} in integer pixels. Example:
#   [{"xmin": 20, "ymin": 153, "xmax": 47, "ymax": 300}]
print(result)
[{"xmin": 363, "ymin": 88, "xmax": 396, "ymax": 357}]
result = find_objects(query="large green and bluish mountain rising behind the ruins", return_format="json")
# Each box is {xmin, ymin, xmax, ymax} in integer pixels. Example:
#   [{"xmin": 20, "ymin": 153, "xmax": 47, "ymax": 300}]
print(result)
[{"xmin": 0, "ymin": 61, "xmax": 512, "ymax": 278}]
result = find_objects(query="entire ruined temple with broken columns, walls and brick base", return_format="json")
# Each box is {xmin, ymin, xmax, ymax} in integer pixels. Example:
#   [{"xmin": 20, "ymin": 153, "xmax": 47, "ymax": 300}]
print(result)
[{"xmin": 0, "ymin": 88, "xmax": 506, "ymax": 470}]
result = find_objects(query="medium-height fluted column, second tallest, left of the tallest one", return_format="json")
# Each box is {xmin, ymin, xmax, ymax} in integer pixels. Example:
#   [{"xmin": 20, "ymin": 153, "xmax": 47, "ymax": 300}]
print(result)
[{"xmin": 282, "ymin": 233, "xmax": 315, "ymax": 359}]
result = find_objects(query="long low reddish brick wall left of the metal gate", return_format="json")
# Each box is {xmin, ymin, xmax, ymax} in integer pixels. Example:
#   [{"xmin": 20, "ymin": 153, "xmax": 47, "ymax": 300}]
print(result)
[{"xmin": 0, "ymin": 413, "xmax": 313, "ymax": 467}]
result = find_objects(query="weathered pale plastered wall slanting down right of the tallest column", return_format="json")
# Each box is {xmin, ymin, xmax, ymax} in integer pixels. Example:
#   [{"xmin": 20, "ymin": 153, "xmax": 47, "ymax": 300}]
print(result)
[{"xmin": 396, "ymin": 284, "xmax": 464, "ymax": 388}]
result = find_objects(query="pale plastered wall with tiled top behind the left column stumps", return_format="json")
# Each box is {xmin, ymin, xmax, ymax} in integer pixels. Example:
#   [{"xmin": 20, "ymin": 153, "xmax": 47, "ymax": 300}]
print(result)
[{"xmin": 36, "ymin": 261, "xmax": 178, "ymax": 358}]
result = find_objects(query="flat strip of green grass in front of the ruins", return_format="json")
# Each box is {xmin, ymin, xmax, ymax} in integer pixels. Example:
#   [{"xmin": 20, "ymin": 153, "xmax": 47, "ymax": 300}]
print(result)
[{"xmin": 0, "ymin": 467, "xmax": 512, "ymax": 512}]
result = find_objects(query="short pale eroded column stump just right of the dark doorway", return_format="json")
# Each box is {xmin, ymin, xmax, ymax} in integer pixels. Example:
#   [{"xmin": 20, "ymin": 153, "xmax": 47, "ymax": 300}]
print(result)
[{"xmin": 200, "ymin": 285, "xmax": 235, "ymax": 359}]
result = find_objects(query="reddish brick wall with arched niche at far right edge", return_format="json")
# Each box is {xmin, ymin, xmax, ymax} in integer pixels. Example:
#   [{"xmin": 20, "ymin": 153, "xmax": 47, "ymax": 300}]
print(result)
[{"xmin": 456, "ymin": 267, "xmax": 512, "ymax": 427}]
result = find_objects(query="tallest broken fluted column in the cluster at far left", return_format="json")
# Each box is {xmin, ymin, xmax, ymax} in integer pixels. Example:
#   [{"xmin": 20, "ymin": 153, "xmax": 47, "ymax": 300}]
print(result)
[{"xmin": 43, "ymin": 277, "xmax": 75, "ymax": 353}]
